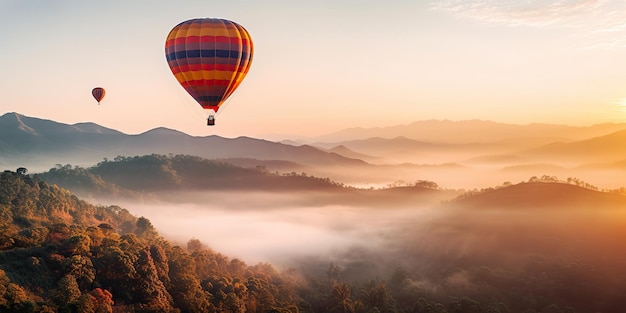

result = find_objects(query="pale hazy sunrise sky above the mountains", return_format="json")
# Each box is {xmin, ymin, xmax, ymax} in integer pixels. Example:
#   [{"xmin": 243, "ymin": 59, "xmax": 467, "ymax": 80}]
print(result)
[{"xmin": 0, "ymin": 0, "xmax": 626, "ymax": 138}]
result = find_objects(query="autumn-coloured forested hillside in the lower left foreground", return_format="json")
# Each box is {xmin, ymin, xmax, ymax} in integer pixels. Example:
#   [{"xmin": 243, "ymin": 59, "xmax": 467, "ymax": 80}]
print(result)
[{"xmin": 0, "ymin": 171, "xmax": 295, "ymax": 312}]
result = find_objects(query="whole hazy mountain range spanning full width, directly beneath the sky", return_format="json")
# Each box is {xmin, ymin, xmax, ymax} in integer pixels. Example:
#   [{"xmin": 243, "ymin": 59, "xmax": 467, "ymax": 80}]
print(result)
[{"xmin": 0, "ymin": 112, "xmax": 626, "ymax": 188}]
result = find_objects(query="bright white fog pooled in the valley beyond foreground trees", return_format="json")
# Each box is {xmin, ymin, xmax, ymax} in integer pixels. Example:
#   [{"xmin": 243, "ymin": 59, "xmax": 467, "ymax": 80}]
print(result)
[{"xmin": 123, "ymin": 193, "xmax": 440, "ymax": 265}]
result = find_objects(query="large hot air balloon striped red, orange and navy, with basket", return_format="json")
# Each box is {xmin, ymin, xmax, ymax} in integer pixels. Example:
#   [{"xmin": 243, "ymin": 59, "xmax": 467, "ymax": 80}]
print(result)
[{"xmin": 165, "ymin": 18, "xmax": 254, "ymax": 125}]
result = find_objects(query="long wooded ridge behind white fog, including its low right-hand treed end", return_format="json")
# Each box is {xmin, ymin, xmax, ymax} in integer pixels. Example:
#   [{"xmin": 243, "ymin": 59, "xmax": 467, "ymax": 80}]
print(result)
[{"xmin": 36, "ymin": 154, "xmax": 459, "ymax": 206}]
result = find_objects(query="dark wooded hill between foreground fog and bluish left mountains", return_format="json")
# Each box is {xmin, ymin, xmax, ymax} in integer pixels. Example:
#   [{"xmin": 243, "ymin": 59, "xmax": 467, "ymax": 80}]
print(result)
[{"xmin": 37, "ymin": 154, "xmax": 342, "ymax": 195}]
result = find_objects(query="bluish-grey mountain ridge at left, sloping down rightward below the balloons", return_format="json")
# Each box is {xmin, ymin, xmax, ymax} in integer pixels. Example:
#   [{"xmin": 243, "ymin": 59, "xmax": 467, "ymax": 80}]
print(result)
[{"xmin": 0, "ymin": 113, "xmax": 365, "ymax": 170}]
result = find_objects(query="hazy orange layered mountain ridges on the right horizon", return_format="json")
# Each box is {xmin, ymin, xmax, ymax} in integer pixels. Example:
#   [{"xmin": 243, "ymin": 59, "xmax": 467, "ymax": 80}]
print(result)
[{"xmin": 312, "ymin": 121, "xmax": 626, "ymax": 166}]
